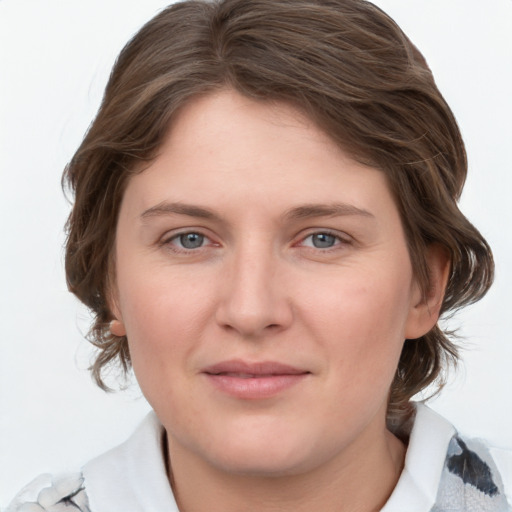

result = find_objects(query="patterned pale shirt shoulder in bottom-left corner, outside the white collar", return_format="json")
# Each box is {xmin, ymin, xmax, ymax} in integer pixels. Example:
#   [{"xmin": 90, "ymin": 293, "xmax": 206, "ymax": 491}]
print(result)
[{"xmin": 5, "ymin": 473, "xmax": 90, "ymax": 512}]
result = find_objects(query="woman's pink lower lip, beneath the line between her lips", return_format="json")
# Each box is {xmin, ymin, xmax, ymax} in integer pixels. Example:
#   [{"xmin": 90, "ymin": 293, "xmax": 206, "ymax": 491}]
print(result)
[{"xmin": 205, "ymin": 373, "xmax": 309, "ymax": 400}]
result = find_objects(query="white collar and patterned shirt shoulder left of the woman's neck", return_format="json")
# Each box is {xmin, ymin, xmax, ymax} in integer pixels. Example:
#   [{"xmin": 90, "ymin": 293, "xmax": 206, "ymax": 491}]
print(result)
[{"xmin": 6, "ymin": 413, "xmax": 178, "ymax": 512}]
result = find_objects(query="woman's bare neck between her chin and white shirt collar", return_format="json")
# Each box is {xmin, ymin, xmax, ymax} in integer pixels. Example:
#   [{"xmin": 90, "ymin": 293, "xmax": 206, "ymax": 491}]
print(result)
[{"xmin": 169, "ymin": 422, "xmax": 405, "ymax": 512}]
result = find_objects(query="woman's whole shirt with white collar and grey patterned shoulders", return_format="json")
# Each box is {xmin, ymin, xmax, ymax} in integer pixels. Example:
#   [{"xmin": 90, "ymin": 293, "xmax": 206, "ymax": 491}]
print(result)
[{"xmin": 6, "ymin": 403, "xmax": 512, "ymax": 512}]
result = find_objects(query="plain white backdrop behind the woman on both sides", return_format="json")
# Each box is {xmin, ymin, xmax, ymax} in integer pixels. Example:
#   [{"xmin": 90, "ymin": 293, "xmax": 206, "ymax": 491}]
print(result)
[{"xmin": 0, "ymin": 0, "xmax": 512, "ymax": 505}]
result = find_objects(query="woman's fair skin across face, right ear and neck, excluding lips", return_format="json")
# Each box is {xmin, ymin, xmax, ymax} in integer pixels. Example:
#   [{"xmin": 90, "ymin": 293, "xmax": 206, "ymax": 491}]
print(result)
[{"xmin": 112, "ymin": 90, "xmax": 447, "ymax": 512}]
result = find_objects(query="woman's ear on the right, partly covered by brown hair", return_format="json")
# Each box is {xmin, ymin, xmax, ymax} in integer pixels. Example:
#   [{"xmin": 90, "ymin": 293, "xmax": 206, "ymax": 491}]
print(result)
[{"xmin": 405, "ymin": 244, "xmax": 450, "ymax": 339}]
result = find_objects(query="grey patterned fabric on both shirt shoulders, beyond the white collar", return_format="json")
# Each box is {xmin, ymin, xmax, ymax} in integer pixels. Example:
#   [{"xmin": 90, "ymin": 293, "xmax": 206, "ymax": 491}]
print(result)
[{"xmin": 5, "ymin": 435, "xmax": 512, "ymax": 512}]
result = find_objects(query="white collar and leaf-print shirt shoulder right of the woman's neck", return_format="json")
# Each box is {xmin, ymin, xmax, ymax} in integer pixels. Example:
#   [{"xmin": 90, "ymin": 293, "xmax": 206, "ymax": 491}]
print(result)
[{"xmin": 382, "ymin": 403, "xmax": 512, "ymax": 512}]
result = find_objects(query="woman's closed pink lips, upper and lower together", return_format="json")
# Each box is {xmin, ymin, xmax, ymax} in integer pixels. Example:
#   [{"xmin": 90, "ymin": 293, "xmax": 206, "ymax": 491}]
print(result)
[{"xmin": 201, "ymin": 359, "xmax": 311, "ymax": 400}]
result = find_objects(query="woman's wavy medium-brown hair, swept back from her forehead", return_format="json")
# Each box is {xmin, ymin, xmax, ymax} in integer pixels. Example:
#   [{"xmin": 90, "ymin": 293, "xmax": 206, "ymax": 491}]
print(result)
[{"xmin": 63, "ymin": 0, "xmax": 493, "ymax": 420}]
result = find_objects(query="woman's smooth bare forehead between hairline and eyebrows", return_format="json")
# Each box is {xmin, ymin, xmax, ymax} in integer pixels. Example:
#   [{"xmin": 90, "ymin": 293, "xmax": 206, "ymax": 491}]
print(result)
[{"xmin": 121, "ymin": 91, "xmax": 400, "ymax": 225}]
